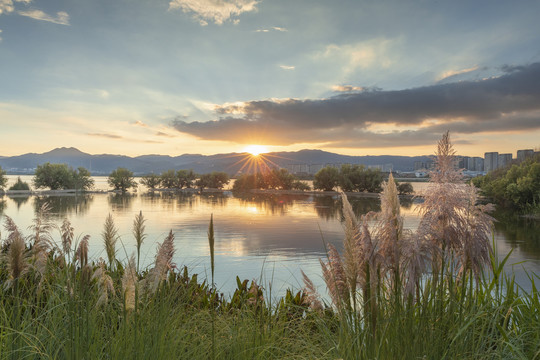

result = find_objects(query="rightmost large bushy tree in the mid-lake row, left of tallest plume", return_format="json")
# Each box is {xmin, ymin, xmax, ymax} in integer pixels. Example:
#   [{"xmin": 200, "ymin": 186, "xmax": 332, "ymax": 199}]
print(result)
[{"xmin": 338, "ymin": 165, "xmax": 383, "ymax": 192}]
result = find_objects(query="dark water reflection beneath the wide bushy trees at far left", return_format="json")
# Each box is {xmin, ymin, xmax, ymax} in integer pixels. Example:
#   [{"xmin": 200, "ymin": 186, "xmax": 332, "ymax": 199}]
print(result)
[{"xmin": 33, "ymin": 195, "xmax": 94, "ymax": 218}]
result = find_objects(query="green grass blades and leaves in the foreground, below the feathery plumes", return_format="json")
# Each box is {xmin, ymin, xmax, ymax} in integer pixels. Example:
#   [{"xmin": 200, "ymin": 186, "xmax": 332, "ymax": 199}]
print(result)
[{"xmin": 0, "ymin": 208, "xmax": 540, "ymax": 359}]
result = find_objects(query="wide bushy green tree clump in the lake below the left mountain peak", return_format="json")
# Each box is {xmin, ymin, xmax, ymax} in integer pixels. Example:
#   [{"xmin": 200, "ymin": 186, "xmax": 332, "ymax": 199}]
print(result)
[{"xmin": 33, "ymin": 163, "xmax": 94, "ymax": 190}]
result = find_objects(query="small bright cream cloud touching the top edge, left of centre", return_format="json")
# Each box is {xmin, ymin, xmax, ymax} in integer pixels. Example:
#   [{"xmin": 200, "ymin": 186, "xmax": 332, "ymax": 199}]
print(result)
[{"xmin": 169, "ymin": 0, "xmax": 258, "ymax": 26}]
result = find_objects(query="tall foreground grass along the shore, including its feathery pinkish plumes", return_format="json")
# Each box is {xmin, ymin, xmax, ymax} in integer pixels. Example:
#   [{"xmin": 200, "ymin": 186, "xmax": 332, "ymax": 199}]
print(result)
[{"xmin": 0, "ymin": 134, "xmax": 540, "ymax": 359}]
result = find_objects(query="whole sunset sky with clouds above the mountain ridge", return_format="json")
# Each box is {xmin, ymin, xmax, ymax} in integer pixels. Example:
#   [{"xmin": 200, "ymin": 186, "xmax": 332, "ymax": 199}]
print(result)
[{"xmin": 0, "ymin": 0, "xmax": 540, "ymax": 157}]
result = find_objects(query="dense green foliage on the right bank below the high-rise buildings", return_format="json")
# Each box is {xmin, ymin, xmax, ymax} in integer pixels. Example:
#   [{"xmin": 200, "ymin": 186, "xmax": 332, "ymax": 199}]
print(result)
[{"xmin": 472, "ymin": 155, "xmax": 540, "ymax": 212}]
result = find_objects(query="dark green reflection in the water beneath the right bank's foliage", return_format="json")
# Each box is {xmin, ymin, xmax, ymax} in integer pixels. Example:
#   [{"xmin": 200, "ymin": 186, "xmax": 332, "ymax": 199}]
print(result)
[{"xmin": 493, "ymin": 211, "xmax": 540, "ymax": 259}]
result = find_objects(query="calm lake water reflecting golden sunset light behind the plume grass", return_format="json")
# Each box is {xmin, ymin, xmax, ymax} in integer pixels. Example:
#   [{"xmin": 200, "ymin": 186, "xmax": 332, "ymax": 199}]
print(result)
[{"xmin": 0, "ymin": 176, "xmax": 540, "ymax": 294}]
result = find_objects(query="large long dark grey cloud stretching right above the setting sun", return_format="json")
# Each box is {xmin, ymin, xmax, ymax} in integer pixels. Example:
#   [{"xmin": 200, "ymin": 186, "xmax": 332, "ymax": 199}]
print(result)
[{"xmin": 172, "ymin": 63, "xmax": 540, "ymax": 147}]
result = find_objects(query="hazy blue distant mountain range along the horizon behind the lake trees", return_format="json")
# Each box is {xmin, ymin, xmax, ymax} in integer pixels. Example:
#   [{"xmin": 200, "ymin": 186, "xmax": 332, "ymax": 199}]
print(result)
[{"xmin": 0, "ymin": 147, "xmax": 429, "ymax": 175}]
